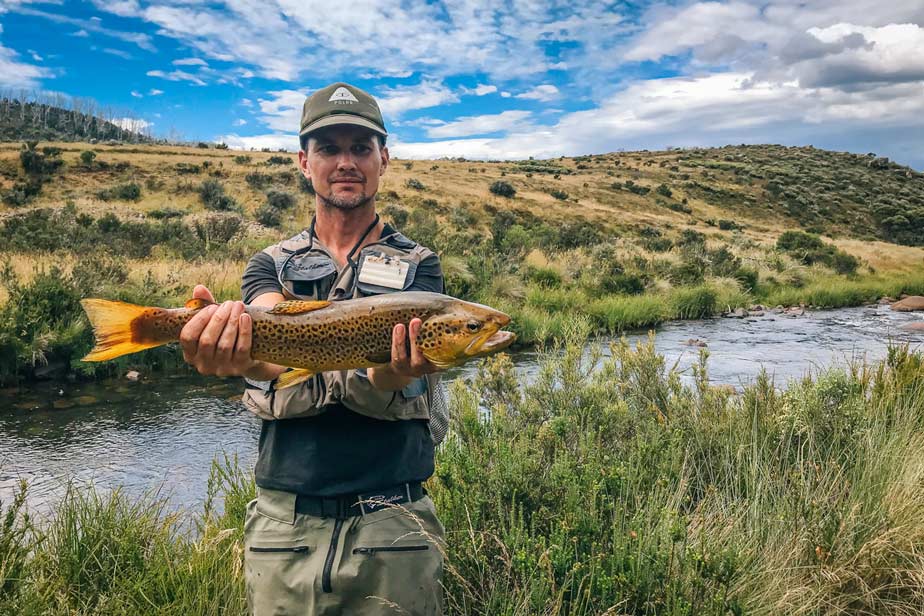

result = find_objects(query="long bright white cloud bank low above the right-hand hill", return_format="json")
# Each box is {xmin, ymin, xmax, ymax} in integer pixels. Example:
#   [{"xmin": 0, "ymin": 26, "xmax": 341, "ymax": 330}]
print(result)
[{"xmin": 391, "ymin": 73, "xmax": 924, "ymax": 164}]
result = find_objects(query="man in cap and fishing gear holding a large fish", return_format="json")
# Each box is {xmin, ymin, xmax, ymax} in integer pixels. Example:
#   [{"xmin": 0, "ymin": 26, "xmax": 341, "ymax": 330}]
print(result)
[{"xmin": 181, "ymin": 83, "xmax": 443, "ymax": 616}]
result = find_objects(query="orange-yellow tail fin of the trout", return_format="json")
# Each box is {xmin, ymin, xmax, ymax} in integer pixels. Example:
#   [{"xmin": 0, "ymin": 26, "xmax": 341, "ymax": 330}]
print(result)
[{"xmin": 80, "ymin": 299, "xmax": 170, "ymax": 361}]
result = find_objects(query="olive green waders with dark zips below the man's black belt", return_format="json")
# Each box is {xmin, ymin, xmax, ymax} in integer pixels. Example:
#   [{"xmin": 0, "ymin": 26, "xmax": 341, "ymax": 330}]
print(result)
[{"xmin": 244, "ymin": 488, "xmax": 443, "ymax": 616}]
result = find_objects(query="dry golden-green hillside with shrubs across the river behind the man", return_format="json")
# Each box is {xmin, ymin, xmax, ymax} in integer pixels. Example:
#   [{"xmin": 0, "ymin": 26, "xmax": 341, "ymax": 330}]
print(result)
[{"xmin": 0, "ymin": 142, "xmax": 924, "ymax": 383}]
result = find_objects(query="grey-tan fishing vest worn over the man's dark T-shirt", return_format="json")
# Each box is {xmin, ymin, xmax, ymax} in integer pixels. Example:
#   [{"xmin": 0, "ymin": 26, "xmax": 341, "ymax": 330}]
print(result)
[{"xmin": 243, "ymin": 230, "xmax": 448, "ymax": 443}]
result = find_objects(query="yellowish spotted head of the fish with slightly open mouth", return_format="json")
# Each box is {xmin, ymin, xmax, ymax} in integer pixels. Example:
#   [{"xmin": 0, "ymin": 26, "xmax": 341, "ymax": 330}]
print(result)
[{"xmin": 417, "ymin": 299, "xmax": 516, "ymax": 368}]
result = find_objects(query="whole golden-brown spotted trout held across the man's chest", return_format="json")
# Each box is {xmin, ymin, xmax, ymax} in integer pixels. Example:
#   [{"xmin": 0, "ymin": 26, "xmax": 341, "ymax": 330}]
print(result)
[{"xmin": 80, "ymin": 291, "xmax": 516, "ymax": 387}]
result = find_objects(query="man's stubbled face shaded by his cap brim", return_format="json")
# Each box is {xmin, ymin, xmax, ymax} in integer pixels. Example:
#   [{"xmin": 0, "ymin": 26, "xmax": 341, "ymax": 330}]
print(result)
[{"xmin": 298, "ymin": 125, "xmax": 388, "ymax": 210}]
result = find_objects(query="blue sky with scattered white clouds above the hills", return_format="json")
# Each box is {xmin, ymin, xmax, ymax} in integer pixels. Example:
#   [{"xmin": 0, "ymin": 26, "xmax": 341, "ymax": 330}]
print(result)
[{"xmin": 0, "ymin": 0, "xmax": 924, "ymax": 169}]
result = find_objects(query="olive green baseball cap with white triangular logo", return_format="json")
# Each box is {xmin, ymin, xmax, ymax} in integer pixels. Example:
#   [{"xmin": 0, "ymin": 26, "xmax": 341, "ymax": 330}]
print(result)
[{"xmin": 298, "ymin": 81, "xmax": 388, "ymax": 137}]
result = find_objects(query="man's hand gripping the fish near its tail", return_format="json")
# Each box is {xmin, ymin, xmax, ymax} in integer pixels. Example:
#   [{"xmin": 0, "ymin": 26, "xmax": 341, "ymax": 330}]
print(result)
[{"xmin": 180, "ymin": 284, "xmax": 285, "ymax": 380}]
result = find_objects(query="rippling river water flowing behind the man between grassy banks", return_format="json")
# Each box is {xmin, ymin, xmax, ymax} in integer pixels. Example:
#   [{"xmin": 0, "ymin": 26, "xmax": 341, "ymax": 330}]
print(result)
[{"xmin": 0, "ymin": 306, "xmax": 924, "ymax": 512}]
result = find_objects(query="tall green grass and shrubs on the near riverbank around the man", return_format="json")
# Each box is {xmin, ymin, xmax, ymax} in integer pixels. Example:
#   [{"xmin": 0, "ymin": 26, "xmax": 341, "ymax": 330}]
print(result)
[{"xmin": 0, "ymin": 332, "xmax": 924, "ymax": 616}]
